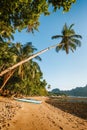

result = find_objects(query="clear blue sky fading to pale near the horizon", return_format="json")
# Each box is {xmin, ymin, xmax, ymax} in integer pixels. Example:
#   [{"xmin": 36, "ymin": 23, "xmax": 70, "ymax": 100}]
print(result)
[{"xmin": 14, "ymin": 0, "xmax": 87, "ymax": 90}]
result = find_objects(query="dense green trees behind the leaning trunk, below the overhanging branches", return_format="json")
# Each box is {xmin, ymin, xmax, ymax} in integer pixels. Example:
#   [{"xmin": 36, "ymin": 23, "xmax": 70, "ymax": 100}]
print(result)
[{"xmin": 0, "ymin": 42, "xmax": 47, "ymax": 95}]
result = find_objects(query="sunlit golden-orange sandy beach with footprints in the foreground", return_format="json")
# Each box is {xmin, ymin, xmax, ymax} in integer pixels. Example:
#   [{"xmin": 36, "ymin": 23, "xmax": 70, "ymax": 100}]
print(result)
[{"xmin": 0, "ymin": 97, "xmax": 87, "ymax": 130}]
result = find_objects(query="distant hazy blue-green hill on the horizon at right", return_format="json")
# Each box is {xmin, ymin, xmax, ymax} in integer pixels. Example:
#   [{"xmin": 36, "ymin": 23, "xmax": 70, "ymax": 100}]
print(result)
[{"xmin": 51, "ymin": 85, "xmax": 87, "ymax": 97}]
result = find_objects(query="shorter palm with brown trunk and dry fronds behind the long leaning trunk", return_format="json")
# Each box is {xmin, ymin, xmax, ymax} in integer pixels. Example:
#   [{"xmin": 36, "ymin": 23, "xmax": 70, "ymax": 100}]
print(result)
[{"xmin": 0, "ymin": 42, "xmax": 41, "ymax": 90}]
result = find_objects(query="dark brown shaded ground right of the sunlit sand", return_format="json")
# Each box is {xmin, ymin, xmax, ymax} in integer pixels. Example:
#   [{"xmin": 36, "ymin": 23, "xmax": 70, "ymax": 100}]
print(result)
[{"xmin": 46, "ymin": 97, "xmax": 87, "ymax": 120}]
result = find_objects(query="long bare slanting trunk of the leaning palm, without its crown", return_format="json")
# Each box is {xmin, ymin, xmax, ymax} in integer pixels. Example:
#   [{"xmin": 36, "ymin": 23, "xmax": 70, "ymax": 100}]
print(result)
[{"xmin": 0, "ymin": 44, "xmax": 60, "ymax": 76}]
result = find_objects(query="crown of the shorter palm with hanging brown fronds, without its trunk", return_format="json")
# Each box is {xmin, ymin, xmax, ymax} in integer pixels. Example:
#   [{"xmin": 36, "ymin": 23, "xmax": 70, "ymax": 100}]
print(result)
[{"xmin": 9, "ymin": 42, "xmax": 41, "ymax": 79}]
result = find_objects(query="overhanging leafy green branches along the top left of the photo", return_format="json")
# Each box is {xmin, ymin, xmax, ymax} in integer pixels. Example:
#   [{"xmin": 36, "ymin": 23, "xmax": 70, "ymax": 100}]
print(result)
[{"xmin": 0, "ymin": 0, "xmax": 76, "ymax": 40}]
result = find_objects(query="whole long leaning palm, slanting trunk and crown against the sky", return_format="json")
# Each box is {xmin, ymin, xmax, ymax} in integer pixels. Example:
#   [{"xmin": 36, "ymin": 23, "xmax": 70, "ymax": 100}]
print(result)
[{"xmin": 0, "ymin": 24, "xmax": 82, "ymax": 76}]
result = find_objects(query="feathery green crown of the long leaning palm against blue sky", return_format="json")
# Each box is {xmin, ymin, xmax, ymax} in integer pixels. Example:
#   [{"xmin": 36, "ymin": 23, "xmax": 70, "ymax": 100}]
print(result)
[{"xmin": 52, "ymin": 23, "xmax": 82, "ymax": 54}]
